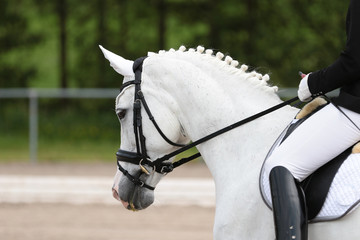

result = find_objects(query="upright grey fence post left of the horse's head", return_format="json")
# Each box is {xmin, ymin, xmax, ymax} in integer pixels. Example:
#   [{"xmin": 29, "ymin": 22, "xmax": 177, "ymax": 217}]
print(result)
[{"xmin": 29, "ymin": 89, "xmax": 38, "ymax": 163}]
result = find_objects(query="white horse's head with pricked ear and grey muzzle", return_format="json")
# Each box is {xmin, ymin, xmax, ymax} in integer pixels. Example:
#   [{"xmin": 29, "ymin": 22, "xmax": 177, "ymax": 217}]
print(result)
[{"xmin": 100, "ymin": 46, "xmax": 189, "ymax": 210}]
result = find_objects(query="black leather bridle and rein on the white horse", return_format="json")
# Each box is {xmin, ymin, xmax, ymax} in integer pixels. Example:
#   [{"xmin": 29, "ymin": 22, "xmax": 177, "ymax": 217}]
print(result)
[{"xmin": 116, "ymin": 57, "xmax": 298, "ymax": 190}]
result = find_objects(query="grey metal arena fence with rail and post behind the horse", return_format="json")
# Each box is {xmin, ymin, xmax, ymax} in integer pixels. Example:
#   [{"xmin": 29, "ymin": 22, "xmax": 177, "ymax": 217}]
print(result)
[{"xmin": 0, "ymin": 88, "xmax": 338, "ymax": 163}]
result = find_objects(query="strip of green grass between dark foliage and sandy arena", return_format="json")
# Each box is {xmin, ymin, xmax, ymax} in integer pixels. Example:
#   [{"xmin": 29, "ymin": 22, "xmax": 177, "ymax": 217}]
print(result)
[{"xmin": 0, "ymin": 135, "xmax": 201, "ymax": 163}]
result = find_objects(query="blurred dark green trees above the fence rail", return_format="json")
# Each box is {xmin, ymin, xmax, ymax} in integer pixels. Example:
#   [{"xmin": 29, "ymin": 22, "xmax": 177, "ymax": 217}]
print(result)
[{"xmin": 0, "ymin": 0, "xmax": 348, "ymax": 88}]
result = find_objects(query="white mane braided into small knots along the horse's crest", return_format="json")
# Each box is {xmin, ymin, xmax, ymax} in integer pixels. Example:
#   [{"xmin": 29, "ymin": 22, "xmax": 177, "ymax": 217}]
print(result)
[{"xmin": 148, "ymin": 46, "xmax": 278, "ymax": 93}]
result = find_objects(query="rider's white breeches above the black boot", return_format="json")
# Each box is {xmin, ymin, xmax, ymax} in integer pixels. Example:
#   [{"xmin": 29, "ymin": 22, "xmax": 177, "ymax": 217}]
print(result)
[{"xmin": 265, "ymin": 104, "xmax": 360, "ymax": 181}]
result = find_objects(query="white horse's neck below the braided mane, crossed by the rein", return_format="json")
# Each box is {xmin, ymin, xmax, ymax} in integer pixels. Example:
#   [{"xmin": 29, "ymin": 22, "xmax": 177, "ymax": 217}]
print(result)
[{"xmin": 145, "ymin": 55, "xmax": 295, "ymax": 182}]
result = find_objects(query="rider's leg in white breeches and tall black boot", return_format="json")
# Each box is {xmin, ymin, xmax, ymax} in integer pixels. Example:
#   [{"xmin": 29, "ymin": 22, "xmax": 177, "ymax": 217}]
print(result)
[{"xmin": 264, "ymin": 104, "xmax": 360, "ymax": 240}]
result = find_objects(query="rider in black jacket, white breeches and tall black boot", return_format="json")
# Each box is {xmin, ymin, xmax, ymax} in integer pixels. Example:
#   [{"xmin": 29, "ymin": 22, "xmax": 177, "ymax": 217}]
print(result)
[{"xmin": 265, "ymin": 0, "xmax": 360, "ymax": 240}]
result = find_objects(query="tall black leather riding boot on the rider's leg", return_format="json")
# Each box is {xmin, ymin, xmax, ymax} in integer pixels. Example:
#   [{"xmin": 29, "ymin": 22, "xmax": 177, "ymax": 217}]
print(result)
[{"xmin": 270, "ymin": 166, "xmax": 308, "ymax": 240}]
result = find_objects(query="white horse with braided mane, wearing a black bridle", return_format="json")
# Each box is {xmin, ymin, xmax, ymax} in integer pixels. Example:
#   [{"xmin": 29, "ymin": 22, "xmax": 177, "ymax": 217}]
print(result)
[{"xmin": 101, "ymin": 47, "xmax": 360, "ymax": 240}]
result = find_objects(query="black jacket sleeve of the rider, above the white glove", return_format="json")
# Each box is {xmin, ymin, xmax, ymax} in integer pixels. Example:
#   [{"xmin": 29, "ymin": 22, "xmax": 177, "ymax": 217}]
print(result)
[{"xmin": 308, "ymin": 0, "xmax": 360, "ymax": 94}]
